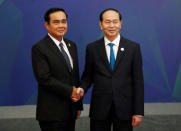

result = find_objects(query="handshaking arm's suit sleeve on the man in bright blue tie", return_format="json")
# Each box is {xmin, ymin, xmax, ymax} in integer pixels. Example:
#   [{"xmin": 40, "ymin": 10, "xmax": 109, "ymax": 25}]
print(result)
[{"xmin": 81, "ymin": 45, "xmax": 93, "ymax": 93}]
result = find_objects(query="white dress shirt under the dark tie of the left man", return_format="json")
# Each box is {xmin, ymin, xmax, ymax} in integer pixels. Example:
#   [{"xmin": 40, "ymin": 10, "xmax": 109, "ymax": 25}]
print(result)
[{"xmin": 48, "ymin": 33, "xmax": 73, "ymax": 69}]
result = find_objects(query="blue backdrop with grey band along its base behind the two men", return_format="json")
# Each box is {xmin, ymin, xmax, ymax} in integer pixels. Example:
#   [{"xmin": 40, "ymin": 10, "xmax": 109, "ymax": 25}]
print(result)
[{"xmin": 0, "ymin": 0, "xmax": 181, "ymax": 131}]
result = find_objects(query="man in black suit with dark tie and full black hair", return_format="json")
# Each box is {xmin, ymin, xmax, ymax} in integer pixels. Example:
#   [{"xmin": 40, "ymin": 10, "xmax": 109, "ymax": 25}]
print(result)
[{"xmin": 32, "ymin": 8, "xmax": 83, "ymax": 131}]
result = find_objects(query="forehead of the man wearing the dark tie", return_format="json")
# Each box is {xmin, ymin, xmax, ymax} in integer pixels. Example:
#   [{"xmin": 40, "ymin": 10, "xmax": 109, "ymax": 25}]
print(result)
[{"xmin": 50, "ymin": 11, "xmax": 67, "ymax": 20}]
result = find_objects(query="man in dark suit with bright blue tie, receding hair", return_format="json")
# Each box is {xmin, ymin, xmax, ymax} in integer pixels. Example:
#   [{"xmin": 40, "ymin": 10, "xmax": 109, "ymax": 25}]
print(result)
[{"xmin": 81, "ymin": 9, "xmax": 144, "ymax": 131}]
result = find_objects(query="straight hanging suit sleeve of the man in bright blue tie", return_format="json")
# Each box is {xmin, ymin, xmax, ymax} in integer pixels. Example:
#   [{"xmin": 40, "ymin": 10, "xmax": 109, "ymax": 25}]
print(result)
[{"xmin": 133, "ymin": 45, "xmax": 144, "ymax": 115}]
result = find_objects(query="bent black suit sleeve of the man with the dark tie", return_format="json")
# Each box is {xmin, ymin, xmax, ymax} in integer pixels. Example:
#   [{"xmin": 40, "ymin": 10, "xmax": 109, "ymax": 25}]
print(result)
[{"xmin": 32, "ymin": 46, "xmax": 73, "ymax": 98}]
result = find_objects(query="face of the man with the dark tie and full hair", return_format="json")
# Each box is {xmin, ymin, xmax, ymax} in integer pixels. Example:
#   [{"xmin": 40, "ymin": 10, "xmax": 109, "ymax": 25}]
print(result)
[{"xmin": 45, "ymin": 11, "xmax": 67, "ymax": 40}]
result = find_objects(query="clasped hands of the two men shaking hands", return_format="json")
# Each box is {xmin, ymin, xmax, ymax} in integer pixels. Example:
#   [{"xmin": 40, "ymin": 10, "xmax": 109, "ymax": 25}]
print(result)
[{"xmin": 70, "ymin": 86, "xmax": 84, "ymax": 102}]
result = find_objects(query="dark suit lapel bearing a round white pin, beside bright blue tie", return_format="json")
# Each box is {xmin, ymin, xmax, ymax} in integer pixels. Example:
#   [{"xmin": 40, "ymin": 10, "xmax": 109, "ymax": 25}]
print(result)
[{"xmin": 114, "ymin": 37, "xmax": 126, "ymax": 71}]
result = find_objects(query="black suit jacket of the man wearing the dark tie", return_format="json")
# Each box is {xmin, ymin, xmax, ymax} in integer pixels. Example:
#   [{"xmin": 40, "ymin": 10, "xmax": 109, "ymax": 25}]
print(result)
[{"xmin": 32, "ymin": 35, "xmax": 82, "ymax": 121}]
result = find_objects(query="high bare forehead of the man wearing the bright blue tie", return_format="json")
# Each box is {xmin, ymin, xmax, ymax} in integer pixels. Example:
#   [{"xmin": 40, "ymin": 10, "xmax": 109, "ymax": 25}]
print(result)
[{"xmin": 102, "ymin": 10, "xmax": 119, "ymax": 20}]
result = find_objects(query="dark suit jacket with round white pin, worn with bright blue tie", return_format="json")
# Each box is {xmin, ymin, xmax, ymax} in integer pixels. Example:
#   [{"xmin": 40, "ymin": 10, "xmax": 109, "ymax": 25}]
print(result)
[{"xmin": 81, "ymin": 37, "xmax": 144, "ymax": 120}]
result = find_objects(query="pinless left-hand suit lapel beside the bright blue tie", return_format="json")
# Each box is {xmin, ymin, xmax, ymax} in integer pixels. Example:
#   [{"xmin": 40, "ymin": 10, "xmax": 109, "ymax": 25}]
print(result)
[{"xmin": 97, "ymin": 38, "xmax": 112, "ymax": 72}]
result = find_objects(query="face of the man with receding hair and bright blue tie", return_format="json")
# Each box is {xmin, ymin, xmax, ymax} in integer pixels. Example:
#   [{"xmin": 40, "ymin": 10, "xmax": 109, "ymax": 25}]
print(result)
[{"xmin": 99, "ymin": 10, "xmax": 122, "ymax": 41}]
